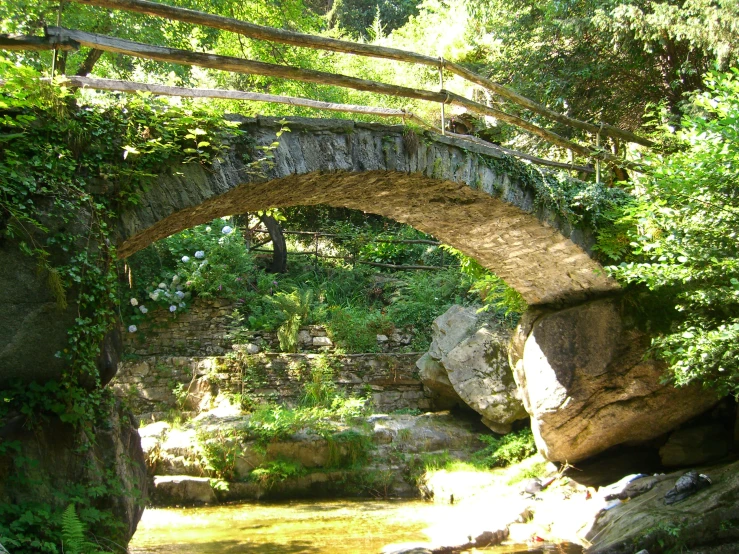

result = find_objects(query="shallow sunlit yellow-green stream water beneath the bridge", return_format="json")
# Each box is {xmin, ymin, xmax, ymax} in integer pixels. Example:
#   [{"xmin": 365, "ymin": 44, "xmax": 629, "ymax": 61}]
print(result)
[{"xmin": 129, "ymin": 500, "xmax": 580, "ymax": 554}]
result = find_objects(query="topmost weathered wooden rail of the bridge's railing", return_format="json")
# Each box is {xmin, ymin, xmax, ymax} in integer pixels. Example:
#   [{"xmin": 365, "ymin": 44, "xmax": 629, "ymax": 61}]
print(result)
[{"xmin": 72, "ymin": 0, "xmax": 654, "ymax": 146}]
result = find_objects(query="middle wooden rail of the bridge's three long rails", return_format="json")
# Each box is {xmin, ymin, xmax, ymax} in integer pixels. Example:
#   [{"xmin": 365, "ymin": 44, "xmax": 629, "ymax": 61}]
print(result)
[{"xmin": 46, "ymin": 27, "xmax": 629, "ymax": 167}]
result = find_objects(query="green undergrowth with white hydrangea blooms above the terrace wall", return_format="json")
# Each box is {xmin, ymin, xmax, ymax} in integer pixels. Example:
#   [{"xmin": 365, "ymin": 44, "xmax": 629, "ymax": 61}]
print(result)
[{"xmin": 130, "ymin": 219, "xmax": 526, "ymax": 353}]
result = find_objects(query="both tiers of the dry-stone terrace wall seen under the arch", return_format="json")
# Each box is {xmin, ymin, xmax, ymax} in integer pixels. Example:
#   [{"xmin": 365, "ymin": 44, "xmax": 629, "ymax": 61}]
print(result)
[{"xmin": 112, "ymin": 300, "xmax": 432, "ymax": 414}]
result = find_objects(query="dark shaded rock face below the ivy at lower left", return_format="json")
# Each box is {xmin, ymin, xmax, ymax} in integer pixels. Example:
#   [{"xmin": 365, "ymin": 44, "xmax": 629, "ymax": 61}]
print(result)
[{"xmin": 0, "ymin": 396, "xmax": 149, "ymax": 545}]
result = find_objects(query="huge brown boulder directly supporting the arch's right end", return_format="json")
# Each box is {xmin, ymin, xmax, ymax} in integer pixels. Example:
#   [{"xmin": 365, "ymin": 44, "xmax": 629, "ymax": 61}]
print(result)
[{"xmin": 509, "ymin": 299, "xmax": 718, "ymax": 462}]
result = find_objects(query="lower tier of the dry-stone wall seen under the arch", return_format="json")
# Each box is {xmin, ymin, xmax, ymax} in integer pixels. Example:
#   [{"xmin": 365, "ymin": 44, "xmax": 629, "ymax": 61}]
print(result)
[{"xmin": 112, "ymin": 353, "xmax": 431, "ymax": 415}]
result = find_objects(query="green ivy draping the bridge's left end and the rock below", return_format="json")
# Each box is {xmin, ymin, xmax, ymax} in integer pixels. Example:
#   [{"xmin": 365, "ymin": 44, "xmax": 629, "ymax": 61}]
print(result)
[{"xmin": 0, "ymin": 59, "xmax": 249, "ymax": 552}]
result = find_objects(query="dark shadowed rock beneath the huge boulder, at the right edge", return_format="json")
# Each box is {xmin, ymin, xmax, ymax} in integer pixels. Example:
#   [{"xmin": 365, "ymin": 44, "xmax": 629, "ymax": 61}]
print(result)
[{"xmin": 659, "ymin": 424, "xmax": 731, "ymax": 467}]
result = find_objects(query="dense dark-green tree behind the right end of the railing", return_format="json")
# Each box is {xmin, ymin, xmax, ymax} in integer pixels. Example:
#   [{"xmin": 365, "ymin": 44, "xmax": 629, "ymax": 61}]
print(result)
[{"xmin": 467, "ymin": 0, "xmax": 739, "ymax": 138}]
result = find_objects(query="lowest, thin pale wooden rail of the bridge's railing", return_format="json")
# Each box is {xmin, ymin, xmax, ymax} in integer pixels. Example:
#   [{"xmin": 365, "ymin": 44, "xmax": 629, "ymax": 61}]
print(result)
[{"xmin": 55, "ymin": 75, "xmax": 595, "ymax": 173}]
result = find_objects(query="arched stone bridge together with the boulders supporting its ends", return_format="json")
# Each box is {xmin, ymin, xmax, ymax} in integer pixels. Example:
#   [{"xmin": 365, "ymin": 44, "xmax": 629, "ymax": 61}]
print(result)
[{"xmin": 0, "ymin": 114, "xmax": 716, "ymax": 468}]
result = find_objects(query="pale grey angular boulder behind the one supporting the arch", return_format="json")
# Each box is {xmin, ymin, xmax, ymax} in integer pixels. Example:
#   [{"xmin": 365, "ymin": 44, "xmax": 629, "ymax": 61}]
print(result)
[{"xmin": 416, "ymin": 306, "xmax": 526, "ymax": 433}]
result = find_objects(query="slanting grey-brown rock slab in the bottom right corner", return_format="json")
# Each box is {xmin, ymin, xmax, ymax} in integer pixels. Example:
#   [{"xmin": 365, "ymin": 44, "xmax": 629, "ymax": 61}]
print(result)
[{"xmin": 588, "ymin": 462, "xmax": 739, "ymax": 554}]
